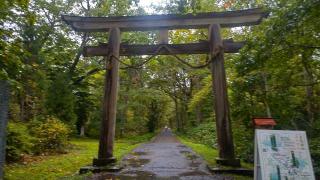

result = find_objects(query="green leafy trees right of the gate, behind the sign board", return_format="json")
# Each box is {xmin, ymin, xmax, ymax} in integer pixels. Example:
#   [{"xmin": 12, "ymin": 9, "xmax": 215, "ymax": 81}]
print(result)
[{"xmin": 228, "ymin": 0, "xmax": 320, "ymax": 166}]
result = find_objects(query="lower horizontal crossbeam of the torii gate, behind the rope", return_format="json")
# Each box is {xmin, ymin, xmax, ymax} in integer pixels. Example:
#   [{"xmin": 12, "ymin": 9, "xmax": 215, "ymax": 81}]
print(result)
[{"xmin": 83, "ymin": 40, "xmax": 244, "ymax": 57}]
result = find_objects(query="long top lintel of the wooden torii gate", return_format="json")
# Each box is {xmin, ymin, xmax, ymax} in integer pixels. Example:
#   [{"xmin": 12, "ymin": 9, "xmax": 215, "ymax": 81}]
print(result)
[{"xmin": 62, "ymin": 8, "xmax": 268, "ymax": 32}]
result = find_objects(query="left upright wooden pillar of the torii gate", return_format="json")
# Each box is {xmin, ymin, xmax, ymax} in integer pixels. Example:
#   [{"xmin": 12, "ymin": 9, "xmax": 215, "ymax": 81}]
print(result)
[{"xmin": 93, "ymin": 28, "xmax": 121, "ymax": 166}]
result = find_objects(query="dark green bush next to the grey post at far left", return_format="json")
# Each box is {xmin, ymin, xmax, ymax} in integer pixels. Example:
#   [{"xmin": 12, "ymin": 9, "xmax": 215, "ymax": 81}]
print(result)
[{"xmin": 6, "ymin": 122, "xmax": 34, "ymax": 162}]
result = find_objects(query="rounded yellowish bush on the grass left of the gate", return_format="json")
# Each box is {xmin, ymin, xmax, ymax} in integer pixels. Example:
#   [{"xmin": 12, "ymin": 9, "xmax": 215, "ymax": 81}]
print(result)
[{"xmin": 33, "ymin": 118, "xmax": 70, "ymax": 153}]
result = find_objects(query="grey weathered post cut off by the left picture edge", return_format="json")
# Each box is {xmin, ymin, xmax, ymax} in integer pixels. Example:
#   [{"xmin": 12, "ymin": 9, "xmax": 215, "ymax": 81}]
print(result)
[{"xmin": 0, "ymin": 80, "xmax": 9, "ymax": 179}]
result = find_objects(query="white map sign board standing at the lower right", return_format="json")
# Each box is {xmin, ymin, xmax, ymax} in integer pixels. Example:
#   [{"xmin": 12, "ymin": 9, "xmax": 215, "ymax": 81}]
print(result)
[{"xmin": 254, "ymin": 129, "xmax": 315, "ymax": 180}]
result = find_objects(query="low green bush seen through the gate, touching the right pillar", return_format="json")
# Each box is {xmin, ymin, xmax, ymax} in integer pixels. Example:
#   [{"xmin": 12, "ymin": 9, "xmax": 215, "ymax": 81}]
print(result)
[{"xmin": 186, "ymin": 122, "xmax": 217, "ymax": 147}]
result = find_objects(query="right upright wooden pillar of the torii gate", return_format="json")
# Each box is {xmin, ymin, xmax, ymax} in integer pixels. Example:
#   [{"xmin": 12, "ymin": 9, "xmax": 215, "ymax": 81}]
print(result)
[{"xmin": 209, "ymin": 24, "xmax": 240, "ymax": 166}]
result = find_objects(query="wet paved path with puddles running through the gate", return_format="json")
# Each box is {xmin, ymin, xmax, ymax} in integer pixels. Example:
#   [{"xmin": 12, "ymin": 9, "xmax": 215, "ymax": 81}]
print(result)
[{"xmin": 90, "ymin": 129, "xmax": 233, "ymax": 180}]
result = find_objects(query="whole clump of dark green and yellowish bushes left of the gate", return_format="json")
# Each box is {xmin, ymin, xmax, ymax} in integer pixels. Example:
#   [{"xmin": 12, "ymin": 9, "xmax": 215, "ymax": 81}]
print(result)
[{"xmin": 6, "ymin": 118, "xmax": 70, "ymax": 162}]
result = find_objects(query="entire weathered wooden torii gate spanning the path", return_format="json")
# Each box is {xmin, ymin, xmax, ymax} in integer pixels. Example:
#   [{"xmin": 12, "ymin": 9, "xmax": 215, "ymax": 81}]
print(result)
[{"xmin": 62, "ymin": 8, "xmax": 267, "ymax": 169}]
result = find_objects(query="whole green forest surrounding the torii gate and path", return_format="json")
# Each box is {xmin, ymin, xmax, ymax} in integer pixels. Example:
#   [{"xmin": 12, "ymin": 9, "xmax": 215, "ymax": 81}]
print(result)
[{"xmin": 0, "ymin": 0, "xmax": 320, "ymax": 179}]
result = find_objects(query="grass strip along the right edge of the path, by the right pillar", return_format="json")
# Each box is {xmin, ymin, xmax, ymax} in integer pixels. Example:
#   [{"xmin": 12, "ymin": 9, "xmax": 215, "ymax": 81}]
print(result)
[{"xmin": 178, "ymin": 136, "xmax": 253, "ymax": 180}]
